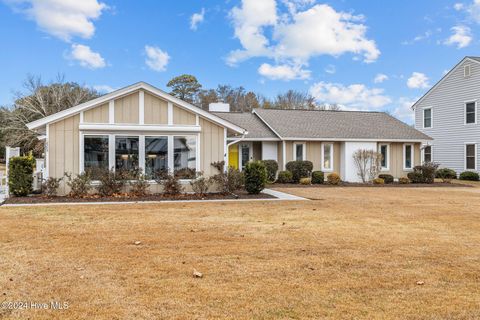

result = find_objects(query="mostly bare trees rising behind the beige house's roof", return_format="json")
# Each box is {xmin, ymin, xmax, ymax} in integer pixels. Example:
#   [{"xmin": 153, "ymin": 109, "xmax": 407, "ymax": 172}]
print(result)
[{"xmin": 0, "ymin": 74, "xmax": 339, "ymax": 159}]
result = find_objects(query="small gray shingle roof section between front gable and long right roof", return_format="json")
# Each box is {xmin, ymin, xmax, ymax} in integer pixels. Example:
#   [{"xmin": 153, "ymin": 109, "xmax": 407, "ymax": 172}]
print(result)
[{"xmin": 212, "ymin": 112, "xmax": 278, "ymax": 139}]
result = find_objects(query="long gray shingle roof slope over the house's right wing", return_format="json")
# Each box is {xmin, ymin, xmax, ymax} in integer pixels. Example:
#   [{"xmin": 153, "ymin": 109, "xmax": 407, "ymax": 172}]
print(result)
[{"xmin": 255, "ymin": 109, "xmax": 431, "ymax": 140}]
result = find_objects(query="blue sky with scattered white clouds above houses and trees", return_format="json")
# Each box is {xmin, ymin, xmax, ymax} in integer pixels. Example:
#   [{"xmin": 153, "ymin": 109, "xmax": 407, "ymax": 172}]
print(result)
[{"xmin": 0, "ymin": 0, "xmax": 480, "ymax": 123}]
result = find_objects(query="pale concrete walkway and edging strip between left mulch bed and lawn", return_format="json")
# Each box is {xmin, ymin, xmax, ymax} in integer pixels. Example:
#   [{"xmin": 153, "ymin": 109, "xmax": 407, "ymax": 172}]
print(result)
[{"xmin": 0, "ymin": 189, "xmax": 309, "ymax": 208}]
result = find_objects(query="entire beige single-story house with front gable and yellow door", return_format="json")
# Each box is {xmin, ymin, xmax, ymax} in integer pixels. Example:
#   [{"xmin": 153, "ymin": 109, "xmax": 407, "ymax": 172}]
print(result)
[{"xmin": 27, "ymin": 82, "xmax": 430, "ymax": 194}]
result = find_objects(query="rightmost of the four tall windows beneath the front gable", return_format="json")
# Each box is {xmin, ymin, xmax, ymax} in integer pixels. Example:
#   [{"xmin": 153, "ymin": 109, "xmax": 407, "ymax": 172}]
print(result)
[{"xmin": 173, "ymin": 136, "xmax": 197, "ymax": 179}]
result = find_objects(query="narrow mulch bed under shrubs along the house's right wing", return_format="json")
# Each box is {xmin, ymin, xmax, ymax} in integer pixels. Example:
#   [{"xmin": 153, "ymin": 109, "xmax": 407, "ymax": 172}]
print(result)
[{"xmin": 268, "ymin": 182, "xmax": 472, "ymax": 188}]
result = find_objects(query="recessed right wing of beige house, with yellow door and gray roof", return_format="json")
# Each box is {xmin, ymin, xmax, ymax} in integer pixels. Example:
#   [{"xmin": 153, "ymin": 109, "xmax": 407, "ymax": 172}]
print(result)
[{"xmin": 211, "ymin": 105, "xmax": 432, "ymax": 182}]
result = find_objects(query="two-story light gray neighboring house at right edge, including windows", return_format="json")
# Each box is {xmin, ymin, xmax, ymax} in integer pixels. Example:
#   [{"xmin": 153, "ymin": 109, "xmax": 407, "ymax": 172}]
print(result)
[{"xmin": 412, "ymin": 57, "xmax": 480, "ymax": 173}]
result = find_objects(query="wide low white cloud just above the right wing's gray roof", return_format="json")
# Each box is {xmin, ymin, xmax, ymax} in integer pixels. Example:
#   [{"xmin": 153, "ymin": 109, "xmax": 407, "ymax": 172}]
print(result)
[{"xmin": 310, "ymin": 82, "xmax": 392, "ymax": 110}]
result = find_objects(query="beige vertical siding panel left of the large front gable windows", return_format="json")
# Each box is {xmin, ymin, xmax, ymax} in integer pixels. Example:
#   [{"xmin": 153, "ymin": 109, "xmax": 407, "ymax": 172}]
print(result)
[{"xmin": 48, "ymin": 114, "xmax": 80, "ymax": 194}]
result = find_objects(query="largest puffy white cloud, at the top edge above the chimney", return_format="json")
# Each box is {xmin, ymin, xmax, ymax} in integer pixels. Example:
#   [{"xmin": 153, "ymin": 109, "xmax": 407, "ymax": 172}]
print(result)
[{"xmin": 227, "ymin": 0, "xmax": 380, "ymax": 78}]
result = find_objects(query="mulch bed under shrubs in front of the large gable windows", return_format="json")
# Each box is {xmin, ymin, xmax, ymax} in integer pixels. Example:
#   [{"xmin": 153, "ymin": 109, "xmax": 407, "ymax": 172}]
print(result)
[{"xmin": 5, "ymin": 191, "xmax": 275, "ymax": 204}]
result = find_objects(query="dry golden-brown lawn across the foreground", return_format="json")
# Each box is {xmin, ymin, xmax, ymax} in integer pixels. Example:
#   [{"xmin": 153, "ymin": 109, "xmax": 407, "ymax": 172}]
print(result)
[{"xmin": 0, "ymin": 187, "xmax": 480, "ymax": 319}]
